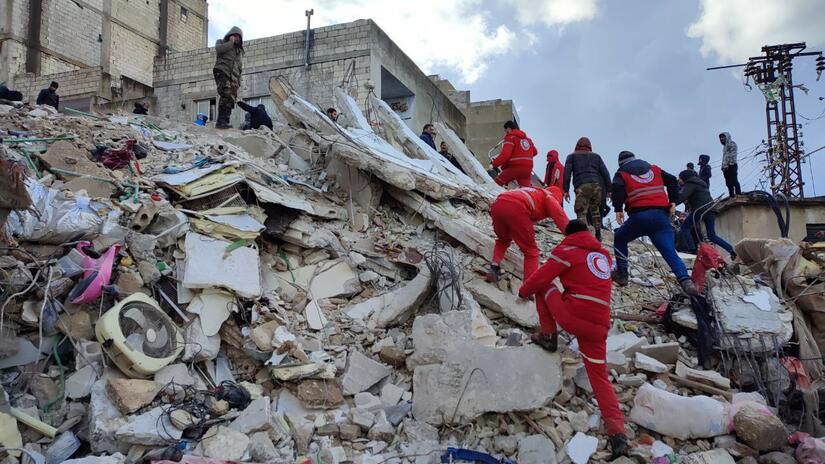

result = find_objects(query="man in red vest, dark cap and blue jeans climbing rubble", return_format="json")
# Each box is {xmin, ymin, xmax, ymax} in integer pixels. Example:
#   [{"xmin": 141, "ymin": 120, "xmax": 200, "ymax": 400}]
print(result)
[{"xmin": 611, "ymin": 151, "xmax": 698, "ymax": 295}]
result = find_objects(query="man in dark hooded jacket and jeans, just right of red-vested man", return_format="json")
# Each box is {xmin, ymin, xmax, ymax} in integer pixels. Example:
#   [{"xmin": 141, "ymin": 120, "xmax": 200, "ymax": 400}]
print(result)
[{"xmin": 679, "ymin": 170, "xmax": 736, "ymax": 258}]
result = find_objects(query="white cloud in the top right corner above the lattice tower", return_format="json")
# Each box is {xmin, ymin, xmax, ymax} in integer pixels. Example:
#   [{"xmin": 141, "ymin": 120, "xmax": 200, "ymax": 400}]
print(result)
[{"xmin": 687, "ymin": 0, "xmax": 825, "ymax": 63}]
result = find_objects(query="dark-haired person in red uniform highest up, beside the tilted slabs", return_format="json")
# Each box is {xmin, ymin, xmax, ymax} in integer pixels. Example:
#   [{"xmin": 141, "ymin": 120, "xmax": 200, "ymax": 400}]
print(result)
[{"xmin": 493, "ymin": 121, "xmax": 538, "ymax": 187}]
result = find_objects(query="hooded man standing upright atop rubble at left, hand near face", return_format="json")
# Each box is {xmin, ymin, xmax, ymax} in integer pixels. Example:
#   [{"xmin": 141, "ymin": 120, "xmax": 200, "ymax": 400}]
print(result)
[{"xmin": 212, "ymin": 26, "xmax": 244, "ymax": 129}]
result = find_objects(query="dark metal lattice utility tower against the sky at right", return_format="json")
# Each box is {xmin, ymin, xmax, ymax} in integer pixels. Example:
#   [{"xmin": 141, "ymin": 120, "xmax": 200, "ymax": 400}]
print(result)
[{"xmin": 708, "ymin": 42, "xmax": 825, "ymax": 198}]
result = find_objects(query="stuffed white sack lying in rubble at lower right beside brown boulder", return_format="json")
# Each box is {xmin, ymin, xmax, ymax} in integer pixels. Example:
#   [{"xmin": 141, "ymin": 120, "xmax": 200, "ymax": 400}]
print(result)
[{"xmin": 630, "ymin": 383, "xmax": 729, "ymax": 440}]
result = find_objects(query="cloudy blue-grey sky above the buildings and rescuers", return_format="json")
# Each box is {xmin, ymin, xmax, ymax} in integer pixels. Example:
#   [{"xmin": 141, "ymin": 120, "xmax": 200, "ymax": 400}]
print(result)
[{"xmin": 209, "ymin": 0, "xmax": 825, "ymax": 196}]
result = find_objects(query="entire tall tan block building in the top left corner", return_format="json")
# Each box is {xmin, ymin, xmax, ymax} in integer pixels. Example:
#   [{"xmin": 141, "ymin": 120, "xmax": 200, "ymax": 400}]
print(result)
[{"xmin": 0, "ymin": 0, "xmax": 208, "ymax": 110}]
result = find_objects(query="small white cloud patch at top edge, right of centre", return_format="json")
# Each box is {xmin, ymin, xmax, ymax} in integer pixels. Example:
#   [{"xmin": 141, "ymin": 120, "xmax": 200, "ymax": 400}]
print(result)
[{"xmin": 499, "ymin": 0, "xmax": 598, "ymax": 26}]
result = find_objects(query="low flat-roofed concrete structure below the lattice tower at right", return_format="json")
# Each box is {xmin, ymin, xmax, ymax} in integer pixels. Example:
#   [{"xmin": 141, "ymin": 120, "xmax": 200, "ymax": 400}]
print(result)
[{"xmin": 716, "ymin": 197, "xmax": 825, "ymax": 245}]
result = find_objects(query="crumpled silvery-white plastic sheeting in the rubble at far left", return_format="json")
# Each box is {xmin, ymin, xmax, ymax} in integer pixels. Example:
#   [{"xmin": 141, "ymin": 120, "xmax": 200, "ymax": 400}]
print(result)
[{"xmin": 7, "ymin": 179, "xmax": 116, "ymax": 245}]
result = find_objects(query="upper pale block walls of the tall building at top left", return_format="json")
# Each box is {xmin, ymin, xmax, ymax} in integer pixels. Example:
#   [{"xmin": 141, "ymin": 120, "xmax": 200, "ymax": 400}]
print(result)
[{"xmin": 0, "ymin": 0, "xmax": 208, "ymax": 91}]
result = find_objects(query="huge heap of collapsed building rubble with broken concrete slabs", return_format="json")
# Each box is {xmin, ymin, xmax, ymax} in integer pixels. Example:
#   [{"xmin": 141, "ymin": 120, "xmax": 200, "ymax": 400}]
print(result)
[{"xmin": 0, "ymin": 79, "xmax": 825, "ymax": 464}]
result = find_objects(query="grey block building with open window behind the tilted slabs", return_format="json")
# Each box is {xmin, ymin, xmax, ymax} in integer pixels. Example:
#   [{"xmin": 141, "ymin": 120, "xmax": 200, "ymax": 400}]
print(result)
[{"xmin": 154, "ymin": 20, "xmax": 466, "ymax": 137}]
